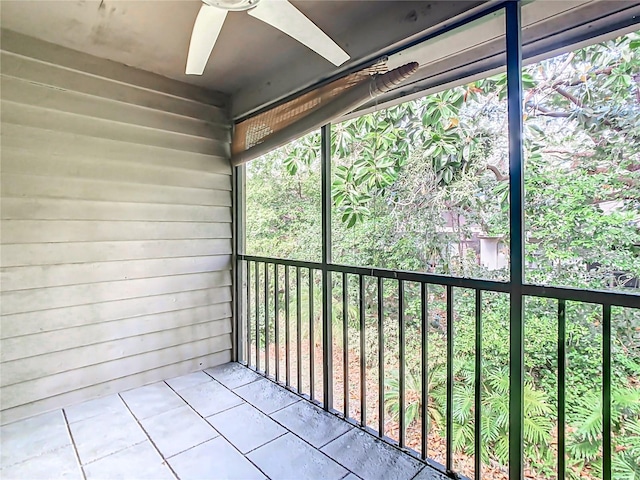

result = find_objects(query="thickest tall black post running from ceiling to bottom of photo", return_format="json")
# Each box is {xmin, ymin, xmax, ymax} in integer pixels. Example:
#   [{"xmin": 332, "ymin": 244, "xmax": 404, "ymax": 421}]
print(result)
[{"xmin": 505, "ymin": 2, "xmax": 524, "ymax": 480}]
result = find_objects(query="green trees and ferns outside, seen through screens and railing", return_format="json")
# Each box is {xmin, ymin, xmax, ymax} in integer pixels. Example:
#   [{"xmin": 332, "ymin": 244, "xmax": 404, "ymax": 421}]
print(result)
[{"xmin": 247, "ymin": 34, "xmax": 640, "ymax": 480}]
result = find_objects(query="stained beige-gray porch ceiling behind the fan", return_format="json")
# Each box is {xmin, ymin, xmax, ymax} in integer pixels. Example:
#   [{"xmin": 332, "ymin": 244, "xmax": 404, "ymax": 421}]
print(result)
[{"xmin": 0, "ymin": 0, "xmax": 483, "ymax": 116}]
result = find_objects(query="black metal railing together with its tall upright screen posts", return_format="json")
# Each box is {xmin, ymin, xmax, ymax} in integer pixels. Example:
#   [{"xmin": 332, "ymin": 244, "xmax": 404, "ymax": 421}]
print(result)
[{"xmin": 233, "ymin": 1, "xmax": 640, "ymax": 480}]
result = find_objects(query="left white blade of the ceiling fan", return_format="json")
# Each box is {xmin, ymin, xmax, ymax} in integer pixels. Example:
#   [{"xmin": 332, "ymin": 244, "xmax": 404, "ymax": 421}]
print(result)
[{"xmin": 185, "ymin": 4, "xmax": 227, "ymax": 75}]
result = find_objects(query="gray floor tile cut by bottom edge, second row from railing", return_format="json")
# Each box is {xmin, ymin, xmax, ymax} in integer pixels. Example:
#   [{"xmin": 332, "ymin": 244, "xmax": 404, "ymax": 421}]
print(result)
[{"xmin": 247, "ymin": 433, "xmax": 348, "ymax": 480}]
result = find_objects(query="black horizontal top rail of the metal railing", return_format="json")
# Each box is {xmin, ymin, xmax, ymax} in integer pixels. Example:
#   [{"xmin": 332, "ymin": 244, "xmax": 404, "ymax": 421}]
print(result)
[{"xmin": 238, "ymin": 255, "xmax": 640, "ymax": 308}]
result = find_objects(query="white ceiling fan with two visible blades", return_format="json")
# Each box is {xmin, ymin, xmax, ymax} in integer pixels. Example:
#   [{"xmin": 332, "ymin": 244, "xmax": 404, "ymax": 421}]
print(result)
[{"xmin": 186, "ymin": 0, "xmax": 349, "ymax": 75}]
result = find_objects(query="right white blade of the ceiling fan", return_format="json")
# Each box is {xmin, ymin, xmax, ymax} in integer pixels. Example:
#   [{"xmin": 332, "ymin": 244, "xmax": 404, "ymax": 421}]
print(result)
[{"xmin": 248, "ymin": 0, "xmax": 349, "ymax": 66}]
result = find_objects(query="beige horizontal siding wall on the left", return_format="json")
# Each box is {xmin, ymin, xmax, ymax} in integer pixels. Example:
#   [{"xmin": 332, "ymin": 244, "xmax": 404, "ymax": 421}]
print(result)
[{"xmin": 0, "ymin": 31, "xmax": 232, "ymax": 423}]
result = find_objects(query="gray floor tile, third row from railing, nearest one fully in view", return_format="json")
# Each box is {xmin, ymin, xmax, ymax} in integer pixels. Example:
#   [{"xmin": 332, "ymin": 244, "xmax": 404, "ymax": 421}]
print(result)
[{"xmin": 140, "ymin": 405, "xmax": 218, "ymax": 458}]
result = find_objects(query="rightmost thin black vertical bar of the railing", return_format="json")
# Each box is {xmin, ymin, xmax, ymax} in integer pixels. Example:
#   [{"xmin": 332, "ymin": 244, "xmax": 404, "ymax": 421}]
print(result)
[{"xmin": 602, "ymin": 304, "xmax": 611, "ymax": 480}]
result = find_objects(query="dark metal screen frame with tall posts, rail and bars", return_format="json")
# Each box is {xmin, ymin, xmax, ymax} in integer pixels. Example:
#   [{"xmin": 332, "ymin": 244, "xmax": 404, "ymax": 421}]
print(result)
[{"xmin": 233, "ymin": 1, "xmax": 640, "ymax": 480}]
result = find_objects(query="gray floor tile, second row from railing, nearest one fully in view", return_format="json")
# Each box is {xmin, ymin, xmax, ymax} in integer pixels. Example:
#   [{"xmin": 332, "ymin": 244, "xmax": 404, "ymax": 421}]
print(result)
[{"xmin": 207, "ymin": 403, "xmax": 287, "ymax": 453}]
